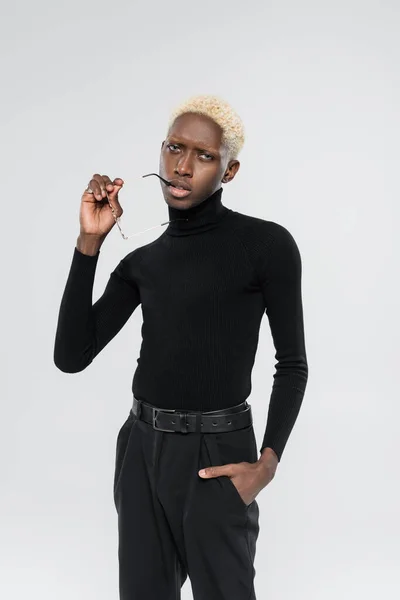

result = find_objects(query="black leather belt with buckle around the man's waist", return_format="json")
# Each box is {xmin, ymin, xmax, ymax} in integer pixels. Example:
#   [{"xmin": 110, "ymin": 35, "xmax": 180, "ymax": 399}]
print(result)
[{"xmin": 131, "ymin": 396, "xmax": 253, "ymax": 433}]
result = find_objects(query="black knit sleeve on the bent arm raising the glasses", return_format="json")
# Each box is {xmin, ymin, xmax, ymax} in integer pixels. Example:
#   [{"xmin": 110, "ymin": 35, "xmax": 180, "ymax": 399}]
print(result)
[{"xmin": 54, "ymin": 247, "xmax": 140, "ymax": 373}]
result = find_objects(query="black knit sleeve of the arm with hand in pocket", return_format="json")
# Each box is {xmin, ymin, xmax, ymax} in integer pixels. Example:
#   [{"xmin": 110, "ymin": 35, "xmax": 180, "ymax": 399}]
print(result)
[{"xmin": 258, "ymin": 223, "xmax": 308, "ymax": 460}]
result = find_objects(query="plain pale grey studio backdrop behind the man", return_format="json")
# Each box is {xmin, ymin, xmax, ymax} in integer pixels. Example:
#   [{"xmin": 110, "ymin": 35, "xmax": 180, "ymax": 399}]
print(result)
[{"xmin": 0, "ymin": 0, "xmax": 400, "ymax": 600}]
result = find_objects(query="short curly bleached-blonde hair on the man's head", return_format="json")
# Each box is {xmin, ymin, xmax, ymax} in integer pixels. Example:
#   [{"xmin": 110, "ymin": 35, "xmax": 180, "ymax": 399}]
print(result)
[{"xmin": 167, "ymin": 94, "xmax": 245, "ymax": 161}]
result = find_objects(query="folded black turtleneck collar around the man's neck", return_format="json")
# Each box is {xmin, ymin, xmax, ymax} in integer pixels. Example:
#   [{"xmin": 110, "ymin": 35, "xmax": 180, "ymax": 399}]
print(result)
[{"xmin": 165, "ymin": 187, "xmax": 230, "ymax": 236}]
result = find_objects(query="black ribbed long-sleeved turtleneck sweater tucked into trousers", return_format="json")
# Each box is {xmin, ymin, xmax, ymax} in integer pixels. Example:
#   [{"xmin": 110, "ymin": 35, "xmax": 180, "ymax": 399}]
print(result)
[{"xmin": 54, "ymin": 188, "xmax": 308, "ymax": 460}]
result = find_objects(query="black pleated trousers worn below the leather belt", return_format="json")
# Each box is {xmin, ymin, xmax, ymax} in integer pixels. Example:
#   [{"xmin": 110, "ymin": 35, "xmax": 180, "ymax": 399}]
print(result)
[{"xmin": 114, "ymin": 400, "xmax": 259, "ymax": 600}]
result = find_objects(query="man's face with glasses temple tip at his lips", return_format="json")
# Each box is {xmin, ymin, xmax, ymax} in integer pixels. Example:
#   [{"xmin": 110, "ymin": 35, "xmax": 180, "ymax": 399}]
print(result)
[{"xmin": 159, "ymin": 113, "xmax": 240, "ymax": 210}]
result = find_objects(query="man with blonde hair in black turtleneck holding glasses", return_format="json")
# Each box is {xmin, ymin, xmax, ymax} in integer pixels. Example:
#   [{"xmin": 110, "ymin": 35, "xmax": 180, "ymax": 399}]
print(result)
[{"xmin": 54, "ymin": 96, "xmax": 308, "ymax": 600}]
